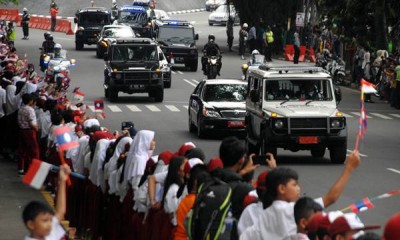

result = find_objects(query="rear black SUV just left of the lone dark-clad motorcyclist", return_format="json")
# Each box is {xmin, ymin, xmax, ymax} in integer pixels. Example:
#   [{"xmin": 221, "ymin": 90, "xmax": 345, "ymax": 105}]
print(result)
[{"xmin": 153, "ymin": 20, "xmax": 199, "ymax": 72}]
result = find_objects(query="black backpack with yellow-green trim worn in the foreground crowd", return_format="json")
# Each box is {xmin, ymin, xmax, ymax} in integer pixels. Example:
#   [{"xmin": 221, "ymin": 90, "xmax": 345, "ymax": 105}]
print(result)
[{"xmin": 186, "ymin": 177, "xmax": 235, "ymax": 240}]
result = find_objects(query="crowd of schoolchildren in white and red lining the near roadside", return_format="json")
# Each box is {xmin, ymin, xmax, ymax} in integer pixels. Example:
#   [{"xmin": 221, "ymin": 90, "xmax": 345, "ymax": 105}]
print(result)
[{"xmin": 0, "ymin": 23, "xmax": 400, "ymax": 240}]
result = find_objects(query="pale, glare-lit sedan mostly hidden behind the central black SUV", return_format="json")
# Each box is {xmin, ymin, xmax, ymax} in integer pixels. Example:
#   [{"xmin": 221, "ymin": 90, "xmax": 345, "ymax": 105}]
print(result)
[{"xmin": 96, "ymin": 25, "xmax": 136, "ymax": 58}]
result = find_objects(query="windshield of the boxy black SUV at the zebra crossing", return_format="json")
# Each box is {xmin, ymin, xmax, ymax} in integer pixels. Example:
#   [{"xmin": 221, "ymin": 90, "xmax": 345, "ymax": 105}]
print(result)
[{"xmin": 112, "ymin": 45, "xmax": 157, "ymax": 61}]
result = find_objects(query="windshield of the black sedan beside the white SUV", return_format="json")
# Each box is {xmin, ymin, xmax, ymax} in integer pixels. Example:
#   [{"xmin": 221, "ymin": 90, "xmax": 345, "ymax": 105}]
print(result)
[{"xmin": 203, "ymin": 84, "xmax": 246, "ymax": 102}]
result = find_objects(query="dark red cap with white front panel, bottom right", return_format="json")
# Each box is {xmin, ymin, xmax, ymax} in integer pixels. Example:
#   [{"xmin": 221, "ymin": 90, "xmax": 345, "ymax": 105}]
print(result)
[{"xmin": 328, "ymin": 213, "xmax": 380, "ymax": 237}]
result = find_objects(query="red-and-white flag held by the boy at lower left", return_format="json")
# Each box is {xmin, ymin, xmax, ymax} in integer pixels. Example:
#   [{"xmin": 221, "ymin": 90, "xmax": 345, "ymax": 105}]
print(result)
[{"xmin": 22, "ymin": 159, "xmax": 51, "ymax": 190}]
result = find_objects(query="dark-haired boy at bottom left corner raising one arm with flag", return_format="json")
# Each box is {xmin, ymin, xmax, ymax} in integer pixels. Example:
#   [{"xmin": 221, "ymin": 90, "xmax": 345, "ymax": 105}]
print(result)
[{"xmin": 22, "ymin": 164, "xmax": 71, "ymax": 239}]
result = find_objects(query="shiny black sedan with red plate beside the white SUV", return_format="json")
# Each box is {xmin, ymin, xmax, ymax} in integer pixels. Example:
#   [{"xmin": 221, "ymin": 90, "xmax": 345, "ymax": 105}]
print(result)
[{"xmin": 188, "ymin": 79, "xmax": 247, "ymax": 138}]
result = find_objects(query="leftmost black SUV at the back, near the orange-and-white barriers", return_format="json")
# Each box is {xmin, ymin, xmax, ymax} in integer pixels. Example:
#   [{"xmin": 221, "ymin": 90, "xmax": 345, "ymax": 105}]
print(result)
[{"xmin": 74, "ymin": 7, "xmax": 111, "ymax": 50}]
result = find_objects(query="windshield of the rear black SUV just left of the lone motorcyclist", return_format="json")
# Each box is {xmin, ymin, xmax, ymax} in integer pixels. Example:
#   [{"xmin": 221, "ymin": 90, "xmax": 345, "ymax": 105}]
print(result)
[{"xmin": 158, "ymin": 26, "xmax": 194, "ymax": 43}]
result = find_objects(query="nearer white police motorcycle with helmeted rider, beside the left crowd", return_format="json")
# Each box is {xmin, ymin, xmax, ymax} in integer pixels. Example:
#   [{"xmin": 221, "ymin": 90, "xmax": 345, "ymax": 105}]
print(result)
[{"xmin": 44, "ymin": 43, "xmax": 75, "ymax": 91}]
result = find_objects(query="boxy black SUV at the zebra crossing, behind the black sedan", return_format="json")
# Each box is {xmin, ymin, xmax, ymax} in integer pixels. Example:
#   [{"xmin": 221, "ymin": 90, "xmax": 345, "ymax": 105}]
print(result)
[{"xmin": 104, "ymin": 38, "xmax": 164, "ymax": 102}]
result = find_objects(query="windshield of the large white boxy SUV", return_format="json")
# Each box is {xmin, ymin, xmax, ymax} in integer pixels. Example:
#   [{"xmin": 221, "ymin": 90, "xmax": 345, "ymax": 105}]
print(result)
[{"xmin": 264, "ymin": 79, "xmax": 333, "ymax": 101}]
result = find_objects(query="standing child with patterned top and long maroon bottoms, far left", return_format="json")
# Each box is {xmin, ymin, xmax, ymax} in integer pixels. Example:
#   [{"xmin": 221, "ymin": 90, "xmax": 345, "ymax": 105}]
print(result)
[{"xmin": 18, "ymin": 93, "xmax": 40, "ymax": 175}]
